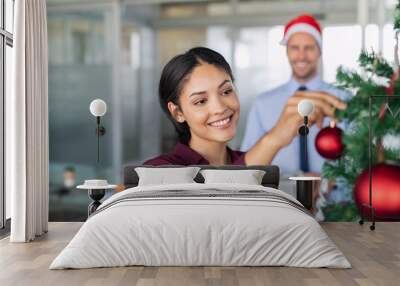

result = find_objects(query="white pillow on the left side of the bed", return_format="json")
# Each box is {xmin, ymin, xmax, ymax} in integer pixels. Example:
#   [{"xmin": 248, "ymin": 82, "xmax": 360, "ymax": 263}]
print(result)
[{"xmin": 135, "ymin": 167, "xmax": 200, "ymax": 186}]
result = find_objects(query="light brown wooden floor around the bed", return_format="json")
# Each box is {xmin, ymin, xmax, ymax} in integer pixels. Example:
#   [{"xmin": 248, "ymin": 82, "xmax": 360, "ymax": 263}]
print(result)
[{"xmin": 0, "ymin": 222, "xmax": 400, "ymax": 286}]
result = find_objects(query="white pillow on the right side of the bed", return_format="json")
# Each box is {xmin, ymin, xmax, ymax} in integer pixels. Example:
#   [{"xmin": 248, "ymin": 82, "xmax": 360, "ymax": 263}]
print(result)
[{"xmin": 200, "ymin": 169, "xmax": 265, "ymax": 185}]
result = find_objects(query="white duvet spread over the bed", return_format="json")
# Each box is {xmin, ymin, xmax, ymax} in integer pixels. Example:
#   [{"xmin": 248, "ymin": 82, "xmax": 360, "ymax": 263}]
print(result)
[{"xmin": 50, "ymin": 183, "xmax": 351, "ymax": 269}]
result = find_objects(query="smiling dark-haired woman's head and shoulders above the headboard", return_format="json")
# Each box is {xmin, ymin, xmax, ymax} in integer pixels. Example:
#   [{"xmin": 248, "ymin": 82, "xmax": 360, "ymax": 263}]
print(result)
[{"xmin": 145, "ymin": 47, "xmax": 245, "ymax": 165}]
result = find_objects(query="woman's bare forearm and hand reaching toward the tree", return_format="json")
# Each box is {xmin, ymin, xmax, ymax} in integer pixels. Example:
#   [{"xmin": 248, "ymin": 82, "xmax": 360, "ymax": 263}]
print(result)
[{"xmin": 245, "ymin": 91, "xmax": 347, "ymax": 165}]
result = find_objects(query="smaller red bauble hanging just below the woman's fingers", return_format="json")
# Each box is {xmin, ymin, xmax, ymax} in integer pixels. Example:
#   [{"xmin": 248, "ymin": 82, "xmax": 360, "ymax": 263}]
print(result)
[{"xmin": 315, "ymin": 126, "xmax": 344, "ymax": 160}]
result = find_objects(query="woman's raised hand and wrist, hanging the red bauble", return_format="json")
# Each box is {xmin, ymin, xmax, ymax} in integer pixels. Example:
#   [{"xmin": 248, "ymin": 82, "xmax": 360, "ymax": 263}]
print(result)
[{"xmin": 270, "ymin": 91, "xmax": 347, "ymax": 148}]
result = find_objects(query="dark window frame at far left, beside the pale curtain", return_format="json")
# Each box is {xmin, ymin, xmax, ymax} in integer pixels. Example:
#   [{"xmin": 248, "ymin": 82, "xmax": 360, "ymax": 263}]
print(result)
[{"xmin": 0, "ymin": 0, "xmax": 15, "ymax": 230}]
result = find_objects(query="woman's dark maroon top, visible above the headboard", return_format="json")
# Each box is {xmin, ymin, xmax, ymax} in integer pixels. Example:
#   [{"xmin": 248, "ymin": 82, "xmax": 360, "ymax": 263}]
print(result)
[{"xmin": 143, "ymin": 143, "xmax": 246, "ymax": 166}]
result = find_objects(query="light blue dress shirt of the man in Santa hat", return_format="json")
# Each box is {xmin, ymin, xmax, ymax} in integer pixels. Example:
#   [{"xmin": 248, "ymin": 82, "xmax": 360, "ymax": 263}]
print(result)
[{"xmin": 241, "ymin": 76, "xmax": 347, "ymax": 174}]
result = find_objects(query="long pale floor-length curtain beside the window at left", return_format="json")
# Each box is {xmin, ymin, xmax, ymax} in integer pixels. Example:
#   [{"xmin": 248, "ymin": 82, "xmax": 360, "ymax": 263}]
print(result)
[{"xmin": 6, "ymin": 0, "xmax": 49, "ymax": 242}]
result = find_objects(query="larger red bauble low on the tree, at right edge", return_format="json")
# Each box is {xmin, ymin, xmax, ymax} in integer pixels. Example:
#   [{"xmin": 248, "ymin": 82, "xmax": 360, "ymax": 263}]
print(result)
[{"xmin": 354, "ymin": 163, "xmax": 400, "ymax": 219}]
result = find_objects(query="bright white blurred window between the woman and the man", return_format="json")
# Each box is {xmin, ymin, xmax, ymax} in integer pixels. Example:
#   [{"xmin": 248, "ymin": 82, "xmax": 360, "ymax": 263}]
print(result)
[{"xmin": 230, "ymin": 26, "xmax": 290, "ymax": 149}]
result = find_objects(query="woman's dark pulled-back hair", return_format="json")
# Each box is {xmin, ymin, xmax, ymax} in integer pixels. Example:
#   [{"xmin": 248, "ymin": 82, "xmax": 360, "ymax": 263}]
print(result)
[{"xmin": 158, "ymin": 47, "xmax": 234, "ymax": 144}]
